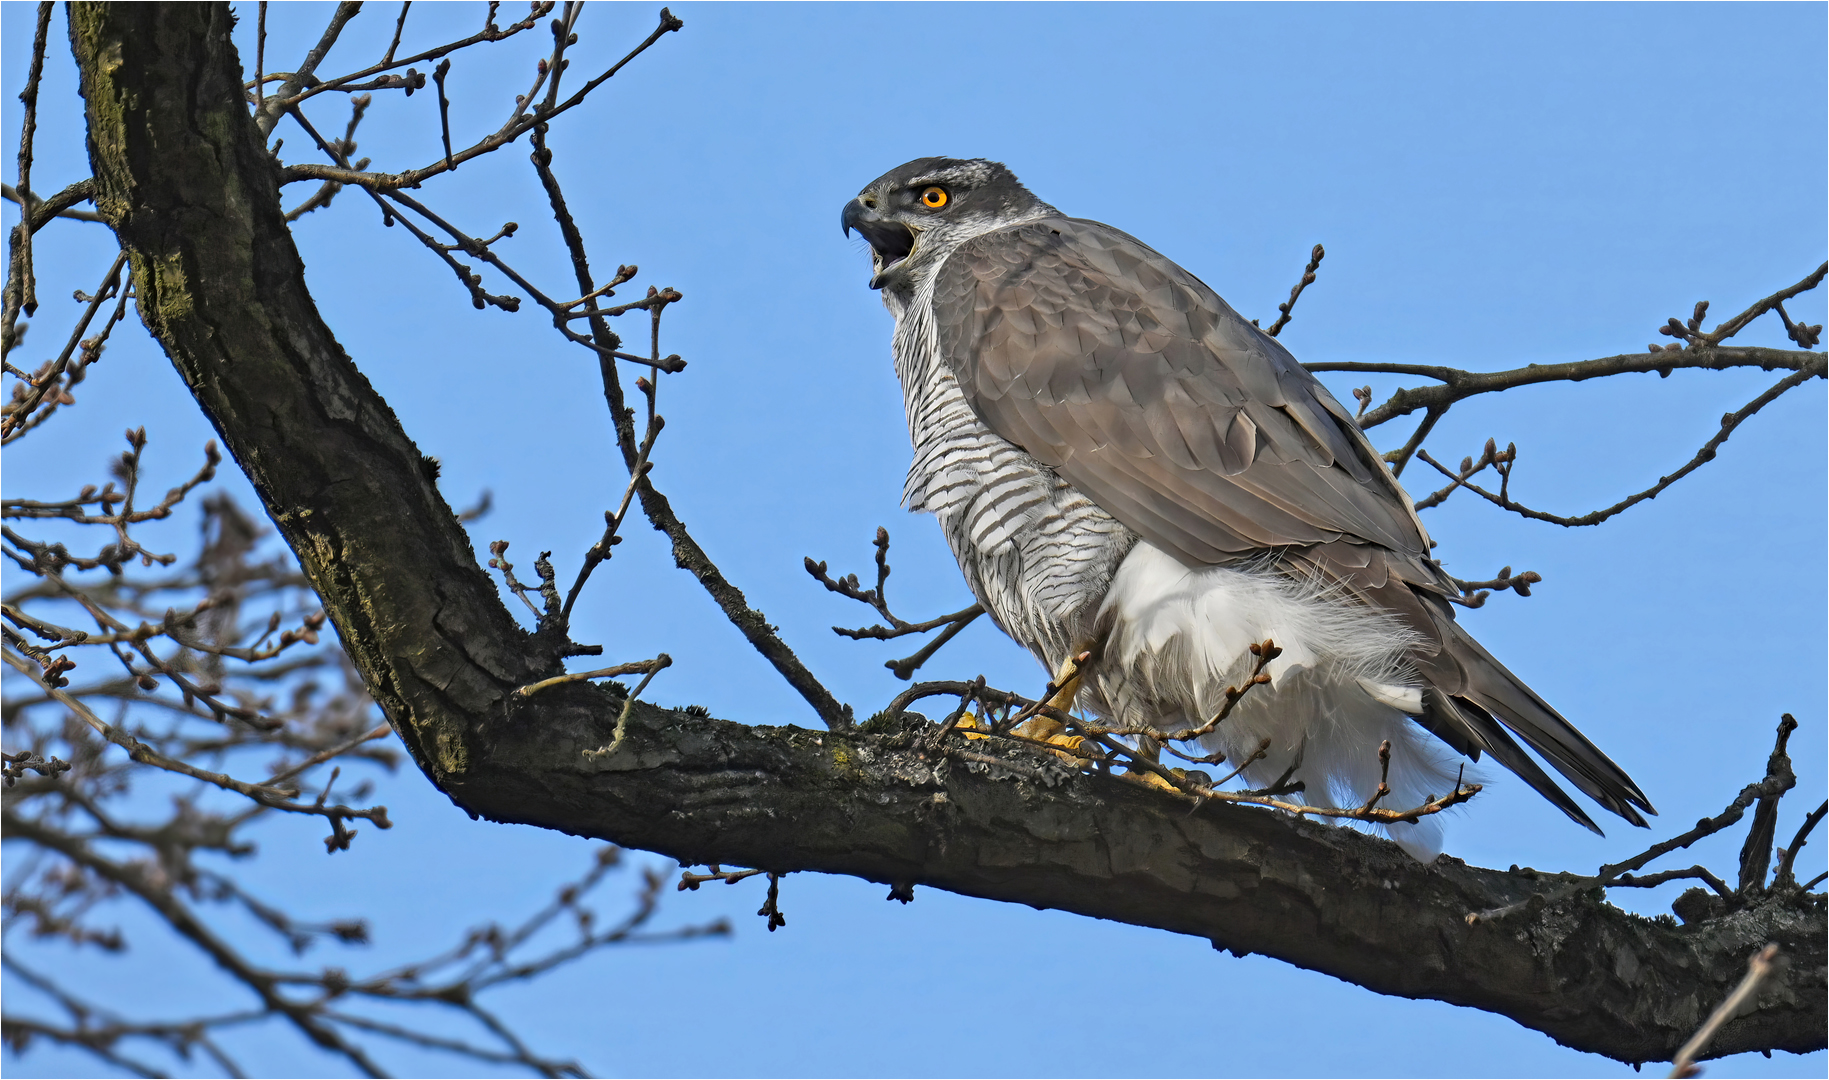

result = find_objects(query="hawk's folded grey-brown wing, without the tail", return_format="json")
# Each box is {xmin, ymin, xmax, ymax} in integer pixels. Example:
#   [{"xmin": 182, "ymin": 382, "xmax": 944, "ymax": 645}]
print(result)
[{"xmin": 933, "ymin": 218, "xmax": 1427, "ymax": 566}]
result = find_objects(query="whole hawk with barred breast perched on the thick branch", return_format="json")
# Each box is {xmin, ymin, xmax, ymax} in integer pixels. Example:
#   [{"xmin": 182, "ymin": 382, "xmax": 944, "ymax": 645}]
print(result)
[{"xmin": 843, "ymin": 157, "xmax": 1655, "ymax": 860}]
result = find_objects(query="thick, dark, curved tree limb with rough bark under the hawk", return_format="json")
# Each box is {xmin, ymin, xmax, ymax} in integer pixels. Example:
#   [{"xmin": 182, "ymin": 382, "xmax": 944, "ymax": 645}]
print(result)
[{"xmin": 70, "ymin": 4, "xmax": 1829, "ymax": 1062}]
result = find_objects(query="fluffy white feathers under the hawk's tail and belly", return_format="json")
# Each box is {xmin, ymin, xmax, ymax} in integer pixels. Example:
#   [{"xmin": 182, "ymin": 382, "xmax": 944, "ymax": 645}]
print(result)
[{"xmin": 1085, "ymin": 542, "xmax": 1456, "ymax": 862}]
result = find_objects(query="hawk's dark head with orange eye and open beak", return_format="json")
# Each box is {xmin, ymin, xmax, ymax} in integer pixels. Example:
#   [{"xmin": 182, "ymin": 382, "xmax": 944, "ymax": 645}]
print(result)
[{"xmin": 840, "ymin": 157, "xmax": 1055, "ymax": 289}]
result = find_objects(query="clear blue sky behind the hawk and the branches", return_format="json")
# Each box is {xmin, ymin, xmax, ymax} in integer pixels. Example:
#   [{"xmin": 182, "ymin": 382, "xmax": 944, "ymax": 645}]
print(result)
[{"xmin": 0, "ymin": 2, "xmax": 1829, "ymax": 1076}]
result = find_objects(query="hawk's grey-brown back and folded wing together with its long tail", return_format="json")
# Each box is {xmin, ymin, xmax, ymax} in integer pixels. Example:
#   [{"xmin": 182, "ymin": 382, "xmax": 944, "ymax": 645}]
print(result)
[{"xmin": 933, "ymin": 218, "xmax": 1652, "ymax": 827}]
